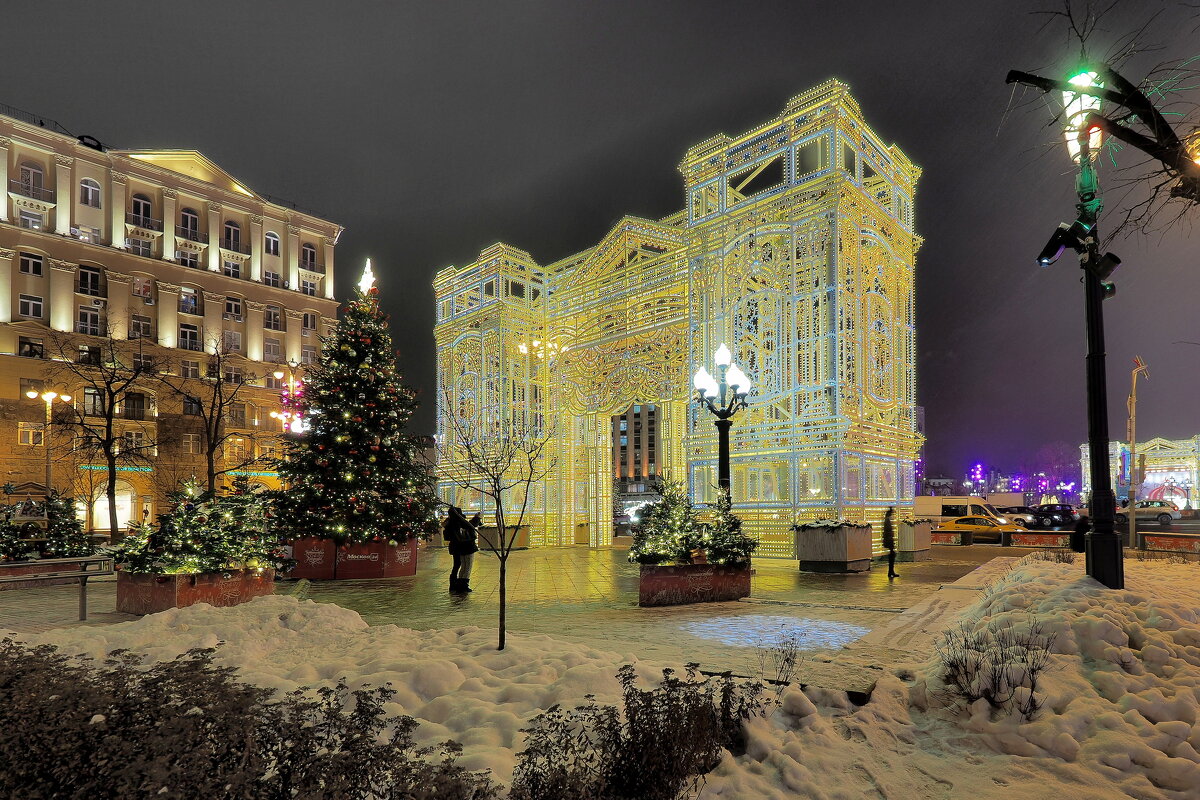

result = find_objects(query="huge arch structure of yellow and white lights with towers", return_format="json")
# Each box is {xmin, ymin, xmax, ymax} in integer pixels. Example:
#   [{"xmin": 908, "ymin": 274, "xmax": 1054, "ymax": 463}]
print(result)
[{"xmin": 434, "ymin": 80, "xmax": 922, "ymax": 558}]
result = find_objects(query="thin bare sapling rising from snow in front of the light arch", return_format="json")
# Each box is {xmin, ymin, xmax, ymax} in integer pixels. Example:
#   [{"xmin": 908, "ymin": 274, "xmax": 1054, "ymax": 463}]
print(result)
[{"xmin": 438, "ymin": 390, "xmax": 554, "ymax": 650}]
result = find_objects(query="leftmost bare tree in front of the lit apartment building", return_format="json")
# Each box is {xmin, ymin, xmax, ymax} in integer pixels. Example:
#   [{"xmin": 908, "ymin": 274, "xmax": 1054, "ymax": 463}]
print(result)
[{"xmin": 47, "ymin": 326, "xmax": 157, "ymax": 537}]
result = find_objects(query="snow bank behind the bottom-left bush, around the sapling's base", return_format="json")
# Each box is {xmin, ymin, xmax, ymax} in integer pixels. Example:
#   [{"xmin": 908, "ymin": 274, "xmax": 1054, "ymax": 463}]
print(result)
[{"xmin": 19, "ymin": 596, "xmax": 661, "ymax": 783}]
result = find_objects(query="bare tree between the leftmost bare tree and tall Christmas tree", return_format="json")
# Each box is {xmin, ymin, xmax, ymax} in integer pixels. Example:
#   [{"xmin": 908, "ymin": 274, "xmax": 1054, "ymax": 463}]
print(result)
[{"xmin": 158, "ymin": 338, "xmax": 266, "ymax": 492}]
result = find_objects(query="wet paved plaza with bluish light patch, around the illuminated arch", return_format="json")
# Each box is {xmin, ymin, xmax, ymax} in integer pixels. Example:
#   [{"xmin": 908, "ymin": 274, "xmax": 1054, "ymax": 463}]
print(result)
[{"xmin": 0, "ymin": 546, "xmax": 1028, "ymax": 688}]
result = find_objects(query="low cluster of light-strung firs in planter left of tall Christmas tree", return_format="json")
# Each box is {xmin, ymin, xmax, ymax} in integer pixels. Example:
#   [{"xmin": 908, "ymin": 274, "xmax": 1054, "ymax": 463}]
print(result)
[{"xmin": 118, "ymin": 477, "xmax": 292, "ymax": 575}]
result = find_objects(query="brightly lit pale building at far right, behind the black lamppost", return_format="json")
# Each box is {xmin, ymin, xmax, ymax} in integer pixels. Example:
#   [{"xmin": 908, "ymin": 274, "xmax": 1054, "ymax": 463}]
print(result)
[{"xmin": 1079, "ymin": 435, "xmax": 1200, "ymax": 509}]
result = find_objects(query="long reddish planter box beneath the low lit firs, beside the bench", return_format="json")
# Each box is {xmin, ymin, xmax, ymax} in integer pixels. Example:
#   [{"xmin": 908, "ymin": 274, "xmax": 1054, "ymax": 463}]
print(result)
[{"xmin": 116, "ymin": 570, "xmax": 275, "ymax": 614}]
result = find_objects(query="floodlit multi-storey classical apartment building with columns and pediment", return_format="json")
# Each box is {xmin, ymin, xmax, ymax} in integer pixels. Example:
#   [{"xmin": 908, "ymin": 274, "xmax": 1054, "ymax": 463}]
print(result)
[{"xmin": 0, "ymin": 109, "xmax": 342, "ymax": 528}]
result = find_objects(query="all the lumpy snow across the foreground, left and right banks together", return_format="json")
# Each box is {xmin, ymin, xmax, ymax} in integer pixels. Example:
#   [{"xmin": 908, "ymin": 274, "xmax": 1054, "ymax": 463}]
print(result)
[{"xmin": 16, "ymin": 561, "xmax": 1200, "ymax": 800}]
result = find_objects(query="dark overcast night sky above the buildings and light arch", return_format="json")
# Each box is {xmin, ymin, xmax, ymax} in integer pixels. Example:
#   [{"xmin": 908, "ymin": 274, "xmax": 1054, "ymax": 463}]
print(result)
[{"xmin": 7, "ymin": 0, "xmax": 1200, "ymax": 471}]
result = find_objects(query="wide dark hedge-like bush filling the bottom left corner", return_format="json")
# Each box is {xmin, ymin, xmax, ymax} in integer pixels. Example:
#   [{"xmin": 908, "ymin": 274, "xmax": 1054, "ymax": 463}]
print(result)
[{"xmin": 0, "ymin": 639, "xmax": 496, "ymax": 800}]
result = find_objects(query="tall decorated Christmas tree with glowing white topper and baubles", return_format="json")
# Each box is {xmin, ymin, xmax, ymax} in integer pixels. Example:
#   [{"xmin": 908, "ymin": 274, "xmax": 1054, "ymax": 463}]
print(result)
[{"xmin": 275, "ymin": 261, "xmax": 437, "ymax": 543}]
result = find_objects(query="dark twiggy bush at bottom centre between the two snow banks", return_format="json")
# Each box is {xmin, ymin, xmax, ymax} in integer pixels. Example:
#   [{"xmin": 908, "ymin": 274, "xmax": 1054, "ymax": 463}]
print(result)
[{"xmin": 509, "ymin": 664, "xmax": 763, "ymax": 800}]
